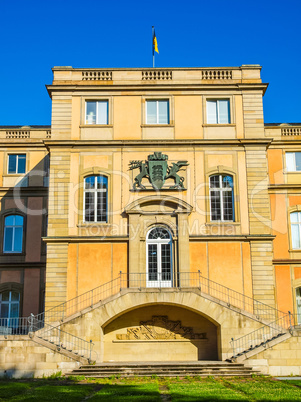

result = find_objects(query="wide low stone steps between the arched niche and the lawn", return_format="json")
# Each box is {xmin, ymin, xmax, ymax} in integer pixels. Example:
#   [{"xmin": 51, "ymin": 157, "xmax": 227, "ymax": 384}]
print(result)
[{"xmin": 65, "ymin": 361, "xmax": 261, "ymax": 378}]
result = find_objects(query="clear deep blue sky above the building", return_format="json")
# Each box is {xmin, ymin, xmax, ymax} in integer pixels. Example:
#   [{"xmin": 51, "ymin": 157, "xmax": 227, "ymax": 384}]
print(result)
[{"xmin": 0, "ymin": 0, "xmax": 301, "ymax": 125}]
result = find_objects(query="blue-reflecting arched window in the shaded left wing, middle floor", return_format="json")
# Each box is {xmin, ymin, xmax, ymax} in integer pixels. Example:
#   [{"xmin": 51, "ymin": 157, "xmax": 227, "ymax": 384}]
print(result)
[{"xmin": 3, "ymin": 215, "xmax": 24, "ymax": 253}]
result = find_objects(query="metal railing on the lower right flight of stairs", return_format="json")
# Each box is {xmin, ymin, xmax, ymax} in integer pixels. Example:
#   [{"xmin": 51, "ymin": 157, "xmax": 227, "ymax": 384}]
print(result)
[{"xmin": 230, "ymin": 312, "xmax": 293, "ymax": 358}]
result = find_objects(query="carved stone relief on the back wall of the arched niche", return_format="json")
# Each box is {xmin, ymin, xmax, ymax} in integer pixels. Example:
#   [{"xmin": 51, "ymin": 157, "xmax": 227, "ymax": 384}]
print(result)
[{"xmin": 116, "ymin": 315, "xmax": 207, "ymax": 341}]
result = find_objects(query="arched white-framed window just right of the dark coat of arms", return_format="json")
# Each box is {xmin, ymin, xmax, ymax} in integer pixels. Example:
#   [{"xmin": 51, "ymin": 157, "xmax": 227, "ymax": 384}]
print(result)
[{"xmin": 209, "ymin": 174, "xmax": 234, "ymax": 222}]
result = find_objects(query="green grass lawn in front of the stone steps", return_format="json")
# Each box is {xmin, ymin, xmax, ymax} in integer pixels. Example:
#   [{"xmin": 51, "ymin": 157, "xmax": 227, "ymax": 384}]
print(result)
[{"xmin": 0, "ymin": 377, "xmax": 301, "ymax": 402}]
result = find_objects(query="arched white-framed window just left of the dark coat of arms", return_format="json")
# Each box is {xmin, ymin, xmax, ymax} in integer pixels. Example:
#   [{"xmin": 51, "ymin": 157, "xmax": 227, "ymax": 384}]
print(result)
[{"xmin": 84, "ymin": 175, "xmax": 108, "ymax": 222}]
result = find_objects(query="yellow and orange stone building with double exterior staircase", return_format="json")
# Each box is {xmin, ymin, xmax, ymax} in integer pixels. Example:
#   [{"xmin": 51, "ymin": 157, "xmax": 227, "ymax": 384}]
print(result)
[{"xmin": 0, "ymin": 65, "xmax": 301, "ymax": 375}]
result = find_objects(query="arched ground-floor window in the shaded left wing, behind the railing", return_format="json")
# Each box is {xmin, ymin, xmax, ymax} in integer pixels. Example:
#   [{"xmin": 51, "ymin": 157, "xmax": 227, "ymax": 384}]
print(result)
[{"xmin": 0, "ymin": 290, "xmax": 20, "ymax": 328}]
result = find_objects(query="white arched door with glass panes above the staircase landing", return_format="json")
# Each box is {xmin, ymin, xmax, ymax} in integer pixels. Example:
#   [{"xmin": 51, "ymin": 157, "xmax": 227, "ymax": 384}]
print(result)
[{"xmin": 146, "ymin": 226, "xmax": 172, "ymax": 287}]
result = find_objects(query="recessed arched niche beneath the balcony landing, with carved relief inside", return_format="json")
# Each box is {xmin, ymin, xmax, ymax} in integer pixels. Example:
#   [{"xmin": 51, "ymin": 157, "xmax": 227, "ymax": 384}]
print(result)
[{"xmin": 103, "ymin": 304, "xmax": 218, "ymax": 361}]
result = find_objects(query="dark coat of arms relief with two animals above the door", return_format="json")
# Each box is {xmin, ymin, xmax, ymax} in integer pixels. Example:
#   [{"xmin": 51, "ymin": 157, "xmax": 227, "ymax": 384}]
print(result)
[{"xmin": 129, "ymin": 152, "xmax": 189, "ymax": 190}]
